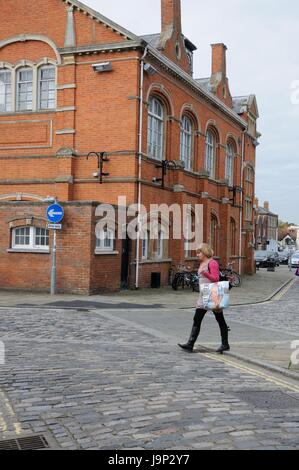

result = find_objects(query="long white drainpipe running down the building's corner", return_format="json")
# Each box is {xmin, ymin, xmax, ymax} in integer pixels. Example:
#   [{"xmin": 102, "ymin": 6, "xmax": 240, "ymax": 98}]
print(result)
[{"xmin": 135, "ymin": 46, "xmax": 148, "ymax": 289}]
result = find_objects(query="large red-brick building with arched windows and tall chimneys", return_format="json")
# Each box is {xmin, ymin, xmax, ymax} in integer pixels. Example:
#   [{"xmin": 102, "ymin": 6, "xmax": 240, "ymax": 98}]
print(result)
[{"xmin": 0, "ymin": 0, "xmax": 259, "ymax": 293}]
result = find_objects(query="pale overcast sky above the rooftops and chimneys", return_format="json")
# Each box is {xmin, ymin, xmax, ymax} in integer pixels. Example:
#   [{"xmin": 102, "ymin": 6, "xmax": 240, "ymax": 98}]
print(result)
[{"xmin": 83, "ymin": 0, "xmax": 299, "ymax": 224}]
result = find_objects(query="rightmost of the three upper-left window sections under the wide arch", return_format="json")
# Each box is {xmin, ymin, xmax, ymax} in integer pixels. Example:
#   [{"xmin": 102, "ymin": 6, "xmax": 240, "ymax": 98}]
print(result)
[{"xmin": 38, "ymin": 65, "xmax": 56, "ymax": 109}]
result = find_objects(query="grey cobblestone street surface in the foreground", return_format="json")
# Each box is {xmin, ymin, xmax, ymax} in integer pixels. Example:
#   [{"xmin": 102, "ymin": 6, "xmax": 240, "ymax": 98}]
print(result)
[{"xmin": 0, "ymin": 294, "xmax": 299, "ymax": 450}]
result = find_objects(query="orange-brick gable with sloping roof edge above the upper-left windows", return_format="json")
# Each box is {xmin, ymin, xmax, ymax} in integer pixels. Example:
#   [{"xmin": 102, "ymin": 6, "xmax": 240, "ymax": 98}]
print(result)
[{"xmin": 0, "ymin": 0, "xmax": 139, "ymax": 53}]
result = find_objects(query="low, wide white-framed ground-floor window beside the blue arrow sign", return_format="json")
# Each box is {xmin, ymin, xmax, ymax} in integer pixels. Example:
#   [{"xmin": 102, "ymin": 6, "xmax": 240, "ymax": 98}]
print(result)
[{"xmin": 12, "ymin": 226, "xmax": 49, "ymax": 251}]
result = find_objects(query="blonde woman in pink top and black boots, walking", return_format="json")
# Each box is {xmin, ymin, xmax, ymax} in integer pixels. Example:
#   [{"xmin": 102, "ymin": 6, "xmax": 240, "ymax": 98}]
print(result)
[{"xmin": 179, "ymin": 243, "xmax": 230, "ymax": 354}]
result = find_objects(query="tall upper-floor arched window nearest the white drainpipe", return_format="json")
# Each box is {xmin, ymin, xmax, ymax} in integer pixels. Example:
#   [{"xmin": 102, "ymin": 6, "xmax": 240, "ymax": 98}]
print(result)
[{"xmin": 147, "ymin": 98, "xmax": 164, "ymax": 161}]
